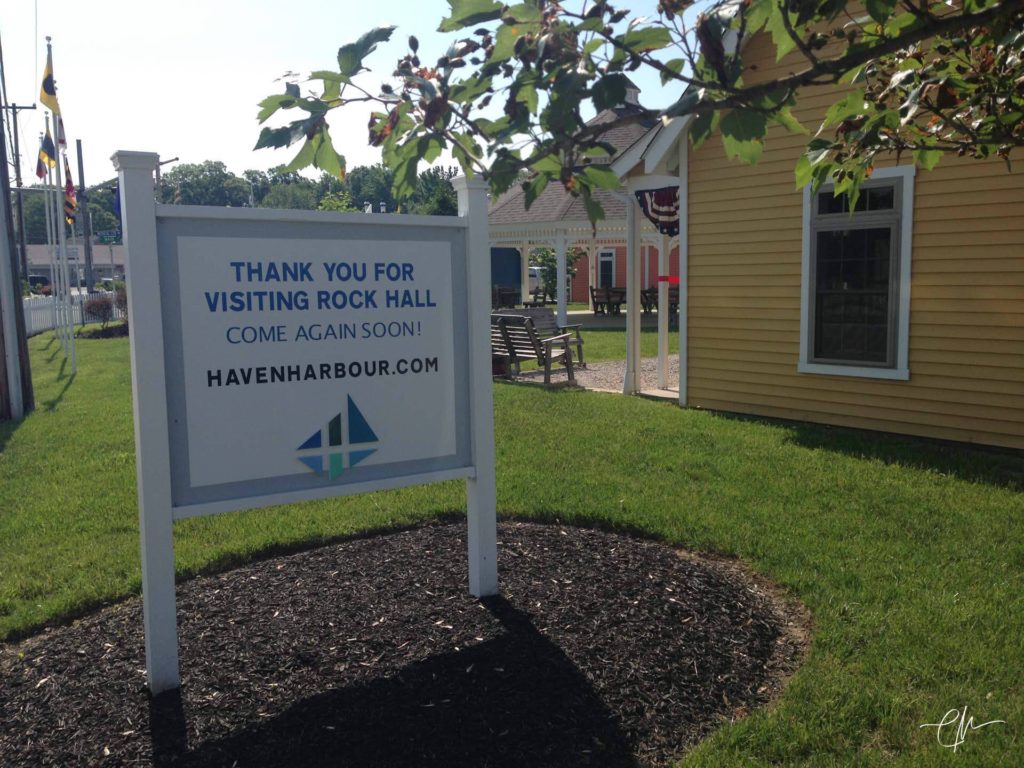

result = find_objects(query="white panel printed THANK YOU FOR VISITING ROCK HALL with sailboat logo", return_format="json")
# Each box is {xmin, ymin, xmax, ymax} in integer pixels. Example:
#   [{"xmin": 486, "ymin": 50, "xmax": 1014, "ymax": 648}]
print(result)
[{"xmin": 177, "ymin": 237, "xmax": 456, "ymax": 487}]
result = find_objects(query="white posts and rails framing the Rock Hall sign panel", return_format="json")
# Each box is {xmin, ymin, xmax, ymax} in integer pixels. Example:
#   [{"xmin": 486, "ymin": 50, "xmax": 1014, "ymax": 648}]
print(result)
[{"xmin": 112, "ymin": 151, "xmax": 498, "ymax": 694}]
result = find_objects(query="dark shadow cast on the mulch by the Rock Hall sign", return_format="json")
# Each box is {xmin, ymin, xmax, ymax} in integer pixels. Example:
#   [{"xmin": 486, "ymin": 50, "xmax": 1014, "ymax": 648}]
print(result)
[{"xmin": 151, "ymin": 597, "xmax": 636, "ymax": 768}]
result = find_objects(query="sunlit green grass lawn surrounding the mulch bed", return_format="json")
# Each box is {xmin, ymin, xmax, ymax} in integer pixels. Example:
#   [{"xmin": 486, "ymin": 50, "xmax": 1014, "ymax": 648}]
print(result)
[{"xmin": 0, "ymin": 332, "xmax": 1024, "ymax": 767}]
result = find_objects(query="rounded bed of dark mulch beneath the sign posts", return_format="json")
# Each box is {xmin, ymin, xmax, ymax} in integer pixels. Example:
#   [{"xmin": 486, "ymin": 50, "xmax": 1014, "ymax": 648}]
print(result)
[{"xmin": 0, "ymin": 523, "xmax": 802, "ymax": 768}]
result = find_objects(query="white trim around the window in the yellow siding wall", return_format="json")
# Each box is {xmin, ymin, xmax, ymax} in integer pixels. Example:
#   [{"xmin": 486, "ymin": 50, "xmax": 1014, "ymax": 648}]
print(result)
[{"xmin": 797, "ymin": 165, "xmax": 916, "ymax": 381}]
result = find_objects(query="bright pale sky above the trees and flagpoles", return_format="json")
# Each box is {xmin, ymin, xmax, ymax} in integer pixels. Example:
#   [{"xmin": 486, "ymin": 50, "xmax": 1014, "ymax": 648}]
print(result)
[{"xmin": 0, "ymin": 0, "xmax": 679, "ymax": 185}]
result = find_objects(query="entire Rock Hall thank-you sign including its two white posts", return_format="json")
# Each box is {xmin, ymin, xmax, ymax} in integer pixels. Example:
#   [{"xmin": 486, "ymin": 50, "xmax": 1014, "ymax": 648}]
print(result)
[{"xmin": 113, "ymin": 152, "xmax": 498, "ymax": 693}]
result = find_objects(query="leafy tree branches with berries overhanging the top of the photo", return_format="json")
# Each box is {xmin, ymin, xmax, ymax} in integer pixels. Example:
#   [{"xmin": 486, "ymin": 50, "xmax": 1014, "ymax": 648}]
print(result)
[{"xmin": 256, "ymin": 0, "xmax": 1024, "ymax": 219}]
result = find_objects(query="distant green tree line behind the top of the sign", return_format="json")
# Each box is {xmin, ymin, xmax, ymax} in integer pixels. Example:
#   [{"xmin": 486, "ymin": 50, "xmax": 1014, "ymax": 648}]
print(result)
[{"xmin": 18, "ymin": 160, "xmax": 458, "ymax": 243}]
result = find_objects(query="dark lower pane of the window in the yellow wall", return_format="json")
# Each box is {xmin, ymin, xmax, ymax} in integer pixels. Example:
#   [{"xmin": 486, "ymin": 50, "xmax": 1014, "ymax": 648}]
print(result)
[{"xmin": 814, "ymin": 227, "xmax": 892, "ymax": 364}]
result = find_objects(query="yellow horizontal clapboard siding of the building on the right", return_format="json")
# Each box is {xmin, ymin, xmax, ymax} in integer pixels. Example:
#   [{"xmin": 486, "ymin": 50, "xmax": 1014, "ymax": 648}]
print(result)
[{"xmin": 687, "ymin": 33, "xmax": 1024, "ymax": 449}]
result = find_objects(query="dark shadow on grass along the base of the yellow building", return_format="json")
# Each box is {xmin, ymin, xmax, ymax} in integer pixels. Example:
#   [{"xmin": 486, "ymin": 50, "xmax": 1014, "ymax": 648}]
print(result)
[{"xmin": 716, "ymin": 413, "xmax": 1024, "ymax": 490}]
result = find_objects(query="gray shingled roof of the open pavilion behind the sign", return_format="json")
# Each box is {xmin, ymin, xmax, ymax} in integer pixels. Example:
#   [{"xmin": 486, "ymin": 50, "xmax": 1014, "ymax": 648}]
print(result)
[{"xmin": 487, "ymin": 104, "xmax": 655, "ymax": 225}]
